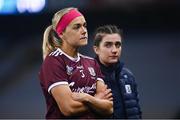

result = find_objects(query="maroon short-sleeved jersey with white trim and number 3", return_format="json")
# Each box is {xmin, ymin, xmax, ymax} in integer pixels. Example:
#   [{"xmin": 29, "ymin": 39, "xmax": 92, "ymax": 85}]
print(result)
[{"xmin": 39, "ymin": 48, "xmax": 103, "ymax": 118}]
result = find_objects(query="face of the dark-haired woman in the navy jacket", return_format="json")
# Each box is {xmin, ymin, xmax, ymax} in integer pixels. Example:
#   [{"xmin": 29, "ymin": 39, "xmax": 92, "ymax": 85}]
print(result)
[{"xmin": 94, "ymin": 34, "xmax": 121, "ymax": 66}]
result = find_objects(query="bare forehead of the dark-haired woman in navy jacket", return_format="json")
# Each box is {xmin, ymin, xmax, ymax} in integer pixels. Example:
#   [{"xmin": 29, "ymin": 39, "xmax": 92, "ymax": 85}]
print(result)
[{"xmin": 102, "ymin": 33, "xmax": 121, "ymax": 43}]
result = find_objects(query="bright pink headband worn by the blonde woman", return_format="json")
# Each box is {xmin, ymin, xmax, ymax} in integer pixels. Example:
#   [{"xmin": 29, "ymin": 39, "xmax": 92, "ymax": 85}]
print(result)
[{"xmin": 56, "ymin": 9, "xmax": 82, "ymax": 35}]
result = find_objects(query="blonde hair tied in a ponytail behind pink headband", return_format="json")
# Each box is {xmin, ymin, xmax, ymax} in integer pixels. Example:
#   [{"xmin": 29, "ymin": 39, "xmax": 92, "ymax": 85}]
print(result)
[{"xmin": 42, "ymin": 7, "xmax": 77, "ymax": 60}]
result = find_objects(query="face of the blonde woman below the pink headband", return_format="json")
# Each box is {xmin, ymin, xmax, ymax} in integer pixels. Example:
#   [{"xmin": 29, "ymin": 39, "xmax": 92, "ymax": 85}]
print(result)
[{"xmin": 60, "ymin": 16, "xmax": 88, "ymax": 47}]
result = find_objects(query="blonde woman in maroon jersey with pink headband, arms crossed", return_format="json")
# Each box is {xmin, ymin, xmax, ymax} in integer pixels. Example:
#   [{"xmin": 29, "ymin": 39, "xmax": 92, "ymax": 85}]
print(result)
[{"xmin": 39, "ymin": 8, "xmax": 113, "ymax": 119}]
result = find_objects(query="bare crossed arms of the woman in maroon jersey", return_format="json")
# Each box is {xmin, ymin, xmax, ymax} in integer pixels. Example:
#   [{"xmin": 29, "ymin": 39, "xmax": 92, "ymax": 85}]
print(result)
[{"xmin": 51, "ymin": 81, "xmax": 113, "ymax": 116}]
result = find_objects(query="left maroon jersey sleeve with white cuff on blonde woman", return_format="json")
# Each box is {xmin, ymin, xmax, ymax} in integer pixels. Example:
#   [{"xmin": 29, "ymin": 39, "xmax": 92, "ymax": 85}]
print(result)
[{"xmin": 40, "ymin": 56, "xmax": 68, "ymax": 93}]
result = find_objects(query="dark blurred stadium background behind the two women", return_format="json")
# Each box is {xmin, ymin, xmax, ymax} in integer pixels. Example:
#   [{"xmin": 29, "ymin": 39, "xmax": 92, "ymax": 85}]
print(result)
[{"xmin": 0, "ymin": 0, "xmax": 180, "ymax": 119}]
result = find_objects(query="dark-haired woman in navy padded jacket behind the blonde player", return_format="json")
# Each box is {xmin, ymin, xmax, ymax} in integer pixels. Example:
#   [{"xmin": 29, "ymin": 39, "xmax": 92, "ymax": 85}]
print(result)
[{"xmin": 94, "ymin": 25, "xmax": 141, "ymax": 119}]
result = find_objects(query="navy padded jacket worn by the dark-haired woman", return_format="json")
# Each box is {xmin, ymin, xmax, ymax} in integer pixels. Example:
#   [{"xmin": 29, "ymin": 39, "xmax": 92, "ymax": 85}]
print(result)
[{"xmin": 96, "ymin": 58, "xmax": 141, "ymax": 119}]
